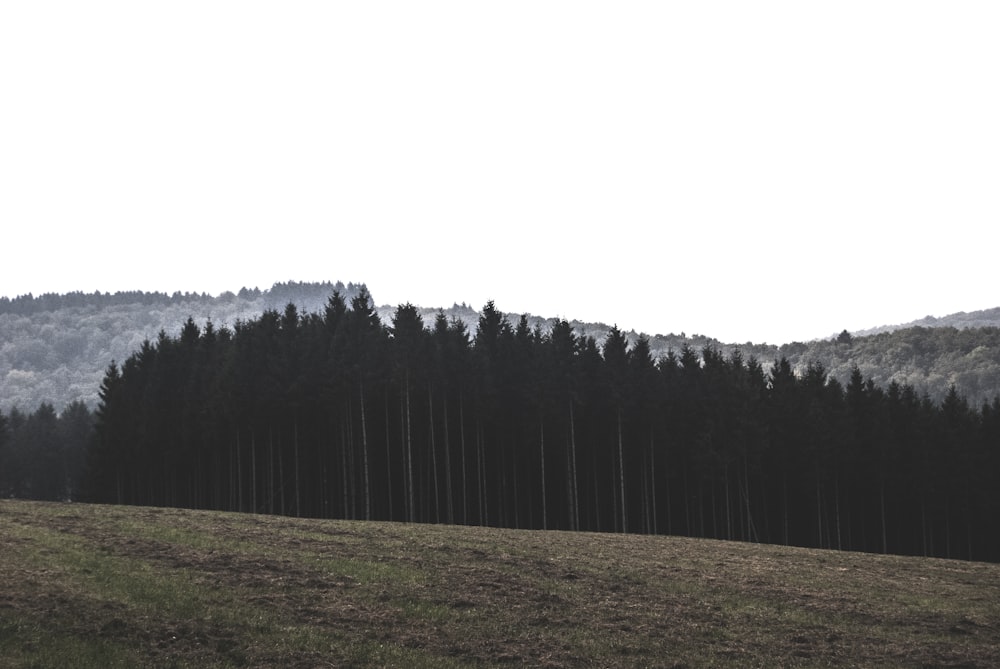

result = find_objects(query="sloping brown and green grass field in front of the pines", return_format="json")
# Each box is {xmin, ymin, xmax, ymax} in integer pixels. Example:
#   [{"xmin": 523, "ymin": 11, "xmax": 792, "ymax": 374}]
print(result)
[{"xmin": 0, "ymin": 500, "xmax": 1000, "ymax": 668}]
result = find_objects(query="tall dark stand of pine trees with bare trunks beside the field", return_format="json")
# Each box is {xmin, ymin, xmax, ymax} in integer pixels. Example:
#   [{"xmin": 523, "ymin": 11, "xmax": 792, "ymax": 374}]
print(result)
[{"xmin": 89, "ymin": 290, "xmax": 1000, "ymax": 561}]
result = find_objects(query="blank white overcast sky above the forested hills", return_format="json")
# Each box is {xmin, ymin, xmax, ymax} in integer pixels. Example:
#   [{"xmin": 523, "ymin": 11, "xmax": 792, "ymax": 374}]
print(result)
[{"xmin": 0, "ymin": 0, "xmax": 1000, "ymax": 344}]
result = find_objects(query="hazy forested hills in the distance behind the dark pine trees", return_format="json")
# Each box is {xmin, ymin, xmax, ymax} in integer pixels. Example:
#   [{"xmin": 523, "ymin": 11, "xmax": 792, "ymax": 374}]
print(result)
[{"xmin": 0, "ymin": 282, "xmax": 1000, "ymax": 411}]
